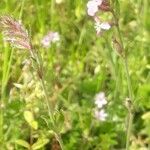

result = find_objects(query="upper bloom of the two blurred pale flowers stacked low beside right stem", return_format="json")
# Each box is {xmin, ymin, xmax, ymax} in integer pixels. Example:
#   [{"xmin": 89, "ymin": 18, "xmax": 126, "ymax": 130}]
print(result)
[{"xmin": 95, "ymin": 92, "xmax": 107, "ymax": 108}]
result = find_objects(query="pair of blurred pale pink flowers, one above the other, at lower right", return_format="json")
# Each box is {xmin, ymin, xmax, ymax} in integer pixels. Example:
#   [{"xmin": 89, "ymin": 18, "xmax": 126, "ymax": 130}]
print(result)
[{"xmin": 94, "ymin": 92, "xmax": 108, "ymax": 121}]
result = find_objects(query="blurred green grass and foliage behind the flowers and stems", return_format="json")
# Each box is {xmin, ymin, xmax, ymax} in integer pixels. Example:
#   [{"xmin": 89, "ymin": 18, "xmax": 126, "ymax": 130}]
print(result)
[{"xmin": 0, "ymin": 0, "xmax": 150, "ymax": 150}]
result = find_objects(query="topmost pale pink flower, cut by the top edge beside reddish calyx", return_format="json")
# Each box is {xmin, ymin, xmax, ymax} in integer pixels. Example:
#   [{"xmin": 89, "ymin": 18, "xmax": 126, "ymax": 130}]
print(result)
[{"xmin": 87, "ymin": 0, "xmax": 103, "ymax": 16}]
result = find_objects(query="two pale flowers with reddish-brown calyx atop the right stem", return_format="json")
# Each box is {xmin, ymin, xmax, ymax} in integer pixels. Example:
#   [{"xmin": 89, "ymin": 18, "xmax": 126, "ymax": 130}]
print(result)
[{"xmin": 87, "ymin": 0, "xmax": 111, "ymax": 34}]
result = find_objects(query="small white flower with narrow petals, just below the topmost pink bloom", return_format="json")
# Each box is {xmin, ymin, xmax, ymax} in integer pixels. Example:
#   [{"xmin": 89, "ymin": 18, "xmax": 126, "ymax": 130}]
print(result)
[{"xmin": 95, "ymin": 21, "xmax": 111, "ymax": 34}]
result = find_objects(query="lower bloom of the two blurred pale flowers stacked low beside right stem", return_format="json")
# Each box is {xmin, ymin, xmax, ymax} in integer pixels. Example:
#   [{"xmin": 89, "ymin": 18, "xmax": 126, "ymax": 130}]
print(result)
[{"xmin": 94, "ymin": 109, "xmax": 108, "ymax": 121}]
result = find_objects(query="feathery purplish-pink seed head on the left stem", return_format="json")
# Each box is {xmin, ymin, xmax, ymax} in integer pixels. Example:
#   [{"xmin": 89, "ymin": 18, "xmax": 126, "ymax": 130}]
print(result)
[{"xmin": 0, "ymin": 16, "xmax": 32, "ymax": 50}]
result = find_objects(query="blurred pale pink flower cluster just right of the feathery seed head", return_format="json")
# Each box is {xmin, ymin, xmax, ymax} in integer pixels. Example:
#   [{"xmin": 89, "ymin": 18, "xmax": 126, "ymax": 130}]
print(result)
[{"xmin": 41, "ymin": 32, "xmax": 60, "ymax": 48}]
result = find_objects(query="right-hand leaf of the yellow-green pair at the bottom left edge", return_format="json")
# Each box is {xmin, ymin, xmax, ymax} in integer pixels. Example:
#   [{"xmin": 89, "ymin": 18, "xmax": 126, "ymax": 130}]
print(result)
[{"xmin": 32, "ymin": 138, "xmax": 49, "ymax": 150}]
